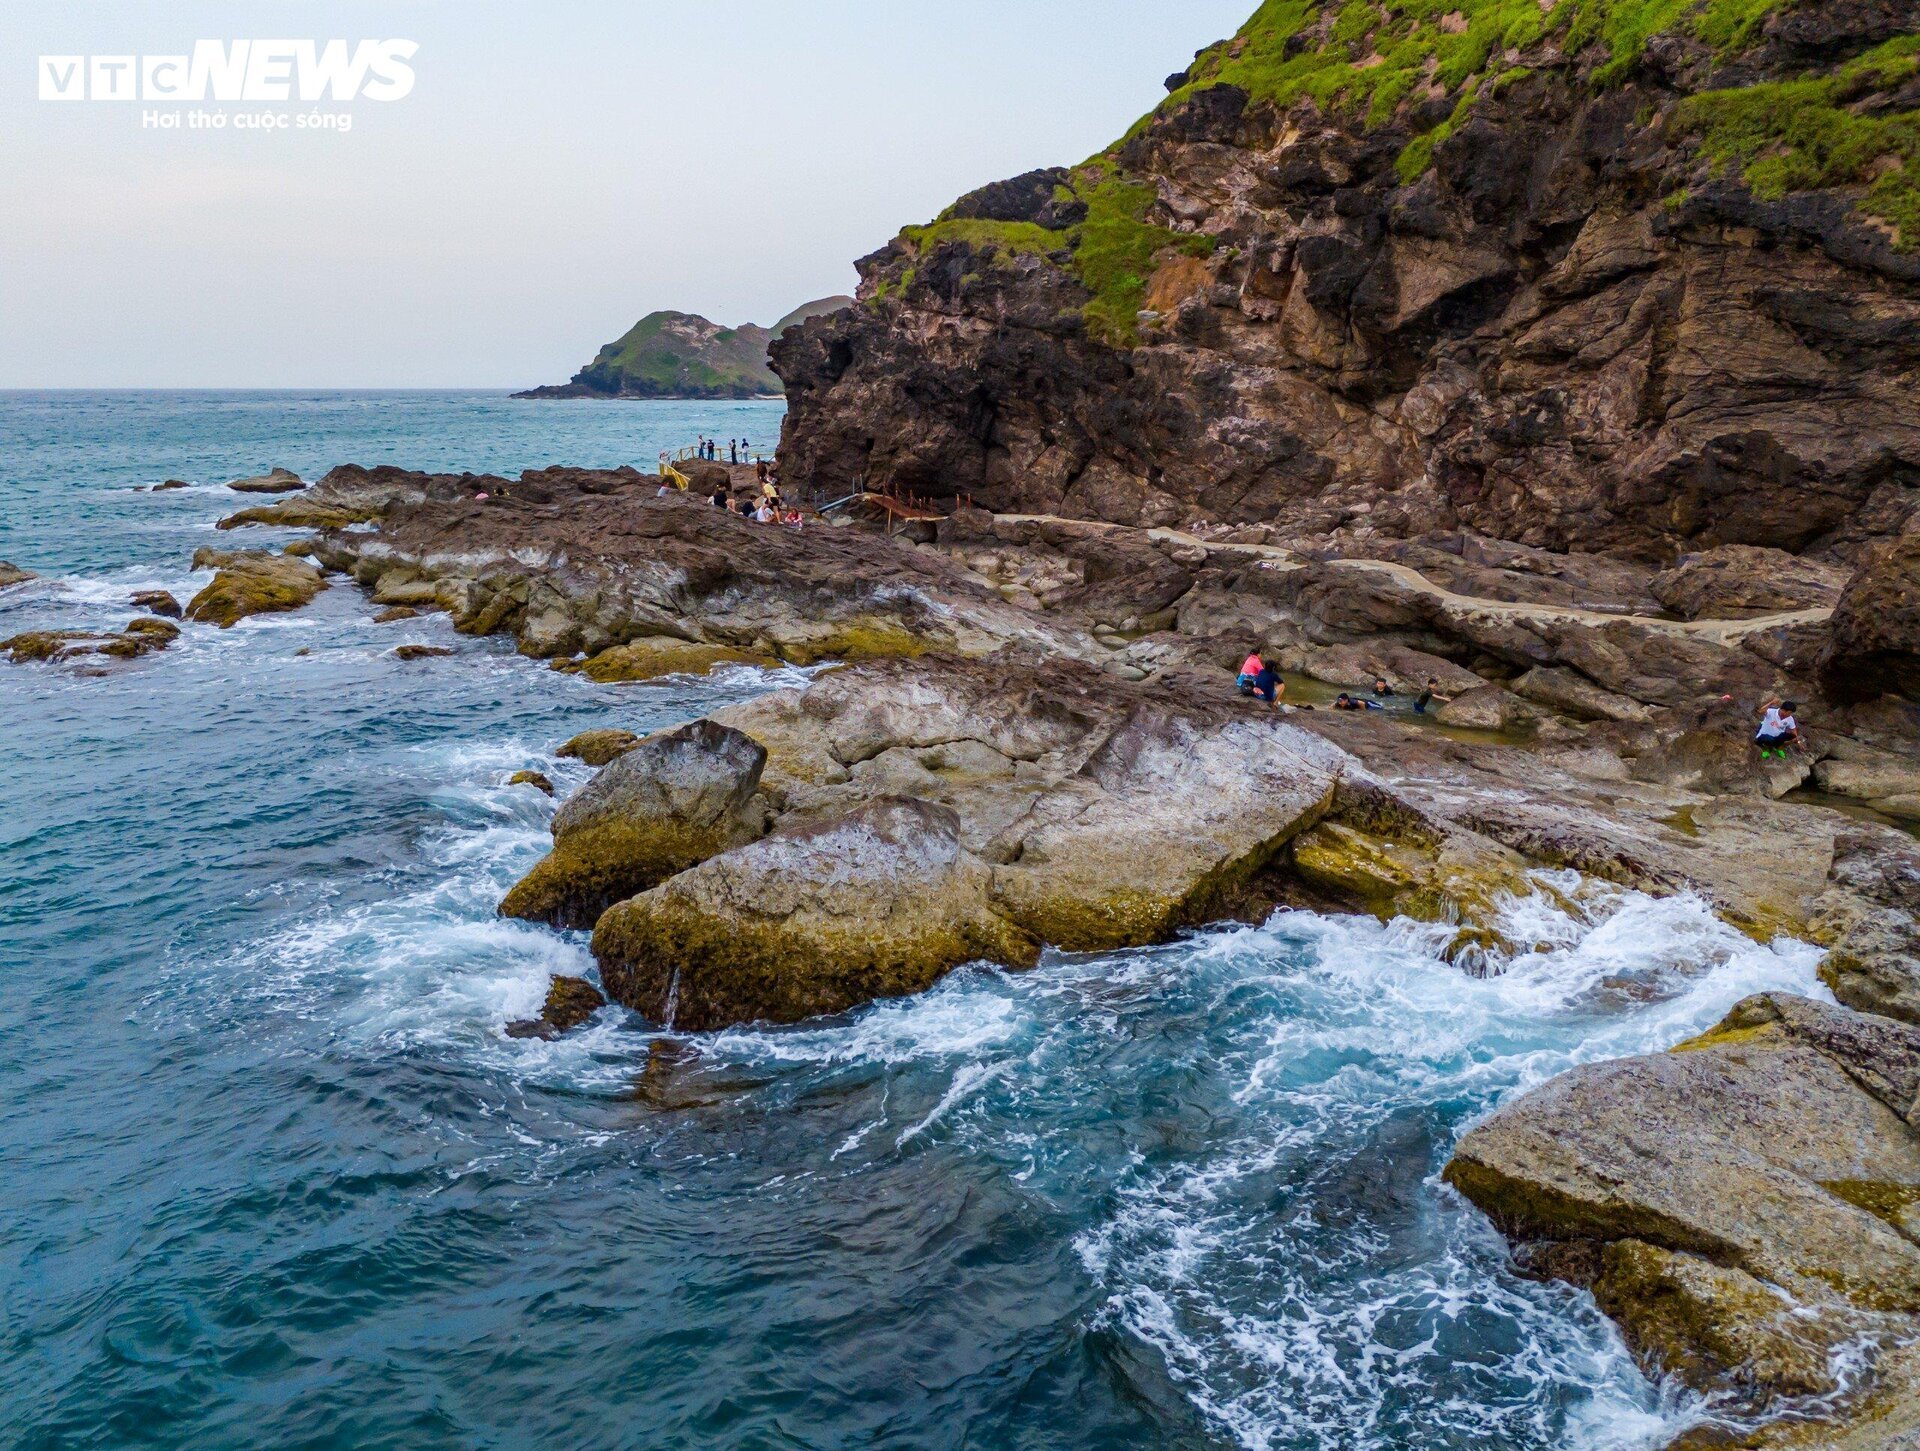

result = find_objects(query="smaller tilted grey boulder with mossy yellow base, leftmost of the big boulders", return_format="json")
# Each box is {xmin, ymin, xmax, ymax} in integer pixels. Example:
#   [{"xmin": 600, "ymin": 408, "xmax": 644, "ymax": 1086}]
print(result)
[{"xmin": 499, "ymin": 720, "xmax": 766, "ymax": 927}]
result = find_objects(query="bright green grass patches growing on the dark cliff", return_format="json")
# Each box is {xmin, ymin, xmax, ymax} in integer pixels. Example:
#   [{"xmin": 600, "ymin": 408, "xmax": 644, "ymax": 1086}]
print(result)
[{"xmin": 894, "ymin": 0, "xmax": 1920, "ymax": 347}]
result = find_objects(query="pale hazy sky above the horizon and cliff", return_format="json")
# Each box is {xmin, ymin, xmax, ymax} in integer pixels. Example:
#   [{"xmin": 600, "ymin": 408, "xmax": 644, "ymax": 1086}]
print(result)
[{"xmin": 0, "ymin": 0, "xmax": 1256, "ymax": 388}]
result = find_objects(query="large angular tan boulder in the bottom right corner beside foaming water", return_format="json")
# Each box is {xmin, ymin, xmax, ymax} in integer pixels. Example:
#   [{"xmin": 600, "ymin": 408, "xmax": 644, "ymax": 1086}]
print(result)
[{"xmin": 1446, "ymin": 994, "xmax": 1920, "ymax": 1443}]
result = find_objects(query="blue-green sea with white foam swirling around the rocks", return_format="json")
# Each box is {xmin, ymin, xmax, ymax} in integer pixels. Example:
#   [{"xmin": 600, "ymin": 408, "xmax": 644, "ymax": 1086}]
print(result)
[{"xmin": 0, "ymin": 392, "xmax": 1820, "ymax": 1451}]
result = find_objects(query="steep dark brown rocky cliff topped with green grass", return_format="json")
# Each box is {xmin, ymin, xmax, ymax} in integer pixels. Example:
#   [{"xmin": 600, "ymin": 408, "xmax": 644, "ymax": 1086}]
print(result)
[{"xmin": 774, "ymin": 0, "xmax": 1920, "ymax": 564}]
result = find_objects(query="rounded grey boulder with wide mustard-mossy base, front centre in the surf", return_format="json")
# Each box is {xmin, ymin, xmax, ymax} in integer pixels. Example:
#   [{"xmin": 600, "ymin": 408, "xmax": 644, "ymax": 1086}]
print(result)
[{"xmin": 593, "ymin": 797, "xmax": 1039, "ymax": 1031}]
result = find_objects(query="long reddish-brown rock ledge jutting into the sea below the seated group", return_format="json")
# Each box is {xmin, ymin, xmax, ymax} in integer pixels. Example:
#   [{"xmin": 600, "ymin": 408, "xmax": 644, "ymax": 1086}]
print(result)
[{"xmin": 295, "ymin": 468, "xmax": 1094, "ymax": 664}]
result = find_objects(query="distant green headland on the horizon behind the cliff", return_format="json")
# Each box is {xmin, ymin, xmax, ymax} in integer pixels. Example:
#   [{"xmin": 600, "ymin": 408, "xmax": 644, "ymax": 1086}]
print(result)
[{"xmin": 515, "ymin": 297, "xmax": 852, "ymax": 399}]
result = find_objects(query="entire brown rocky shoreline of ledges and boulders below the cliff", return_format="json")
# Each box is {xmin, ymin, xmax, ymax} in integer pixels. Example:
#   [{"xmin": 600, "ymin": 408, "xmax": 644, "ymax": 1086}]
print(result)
[{"xmin": 180, "ymin": 451, "xmax": 1920, "ymax": 1447}]
